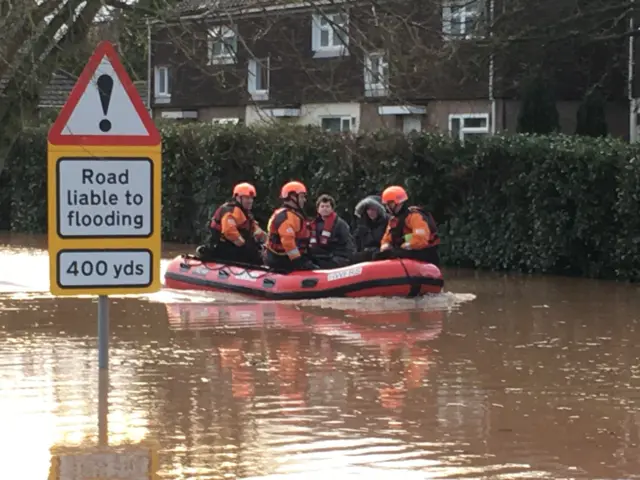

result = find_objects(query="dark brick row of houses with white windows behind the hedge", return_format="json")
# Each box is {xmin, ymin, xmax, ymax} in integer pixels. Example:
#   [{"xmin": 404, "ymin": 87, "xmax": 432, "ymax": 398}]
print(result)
[{"xmin": 150, "ymin": 0, "xmax": 634, "ymax": 138}]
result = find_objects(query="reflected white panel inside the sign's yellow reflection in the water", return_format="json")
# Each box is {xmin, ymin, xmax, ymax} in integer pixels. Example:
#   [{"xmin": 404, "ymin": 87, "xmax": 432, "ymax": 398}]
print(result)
[{"xmin": 58, "ymin": 452, "xmax": 151, "ymax": 480}]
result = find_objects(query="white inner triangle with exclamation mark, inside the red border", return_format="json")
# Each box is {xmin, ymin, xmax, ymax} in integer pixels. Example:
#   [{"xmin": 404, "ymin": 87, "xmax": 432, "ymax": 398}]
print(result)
[{"xmin": 62, "ymin": 57, "xmax": 149, "ymax": 136}]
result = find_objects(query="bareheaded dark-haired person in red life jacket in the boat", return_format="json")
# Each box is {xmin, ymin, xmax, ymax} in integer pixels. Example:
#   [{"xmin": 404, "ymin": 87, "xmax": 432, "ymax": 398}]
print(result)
[{"xmin": 309, "ymin": 194, "xmax": 355, "ymax": 269}]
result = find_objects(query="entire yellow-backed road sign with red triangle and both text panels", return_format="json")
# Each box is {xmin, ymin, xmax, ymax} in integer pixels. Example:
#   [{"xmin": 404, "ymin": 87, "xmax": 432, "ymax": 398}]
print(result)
[{"xmin": 48, "ymin": 42, "xmax": 161, "ymax": 295}]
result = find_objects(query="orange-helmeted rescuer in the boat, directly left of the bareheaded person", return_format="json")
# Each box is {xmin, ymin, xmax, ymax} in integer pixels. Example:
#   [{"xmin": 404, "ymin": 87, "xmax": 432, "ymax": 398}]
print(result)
[{"xmin": 264, "ymin": 181, "xmax": 319, "ymax": 271}]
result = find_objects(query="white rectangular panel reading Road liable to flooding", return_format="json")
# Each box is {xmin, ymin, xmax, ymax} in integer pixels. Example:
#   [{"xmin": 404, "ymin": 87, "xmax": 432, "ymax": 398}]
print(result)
[{"xmin": 57, "ymin": 158, "xmax": 153, "ymax": 238}]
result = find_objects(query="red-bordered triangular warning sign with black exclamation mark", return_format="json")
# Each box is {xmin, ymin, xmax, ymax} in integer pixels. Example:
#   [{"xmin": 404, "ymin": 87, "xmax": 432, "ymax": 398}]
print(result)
[{"xmin": 49, "ymin": 41, "xmax": 161, "ymax": 146}]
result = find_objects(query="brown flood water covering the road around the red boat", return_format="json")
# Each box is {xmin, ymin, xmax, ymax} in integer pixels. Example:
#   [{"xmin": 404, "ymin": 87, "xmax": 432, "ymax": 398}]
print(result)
[{"xmin": 0, "ymin": 233, "xmax": 640, "ymax": 480}]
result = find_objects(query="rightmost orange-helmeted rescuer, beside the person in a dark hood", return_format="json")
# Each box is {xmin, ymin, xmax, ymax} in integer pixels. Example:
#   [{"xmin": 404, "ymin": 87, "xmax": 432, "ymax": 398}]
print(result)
[{"xmin": 374, "ymin": 185, "xmax": 440, "ymax": 266}]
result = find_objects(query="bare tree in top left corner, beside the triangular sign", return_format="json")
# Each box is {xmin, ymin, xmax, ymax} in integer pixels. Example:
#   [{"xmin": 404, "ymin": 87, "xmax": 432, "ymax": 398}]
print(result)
[{"xmin": 0, "ymin": 0, "xmax": 180, "ymax": 172}]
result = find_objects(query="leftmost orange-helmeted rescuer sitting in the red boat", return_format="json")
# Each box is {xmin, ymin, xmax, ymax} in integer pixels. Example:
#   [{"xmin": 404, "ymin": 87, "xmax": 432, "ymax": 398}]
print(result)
[{"xmin": 196, "ymin": 183, "xmax": 267, "ymax": 265}]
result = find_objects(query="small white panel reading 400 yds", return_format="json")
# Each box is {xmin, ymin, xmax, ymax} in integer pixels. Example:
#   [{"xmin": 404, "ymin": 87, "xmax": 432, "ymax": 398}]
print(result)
[{"xmin": 58, "ymin": 250, "xmax": 153, "ymax": 288}]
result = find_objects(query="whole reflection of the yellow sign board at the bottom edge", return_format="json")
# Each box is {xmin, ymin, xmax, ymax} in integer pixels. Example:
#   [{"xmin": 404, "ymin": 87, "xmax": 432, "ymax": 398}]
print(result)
[{"xmin": 49, "ymin": 442, "xmax": 159, "ymax": 480}]
